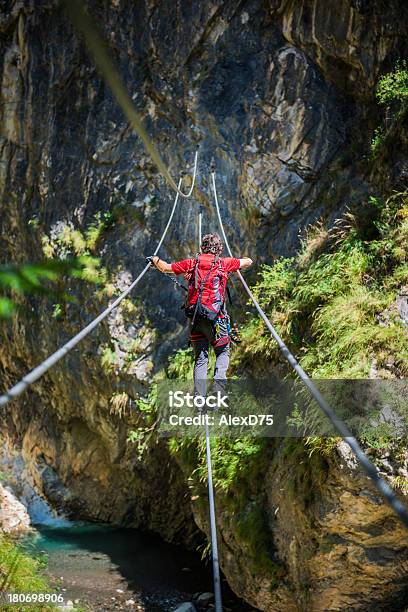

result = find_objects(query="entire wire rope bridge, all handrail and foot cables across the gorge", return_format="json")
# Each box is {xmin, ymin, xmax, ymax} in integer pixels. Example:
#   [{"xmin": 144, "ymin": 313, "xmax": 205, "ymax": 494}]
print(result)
[{"xmin": 0, "ymin": 0, "xmax": 408, "ymax": 612}]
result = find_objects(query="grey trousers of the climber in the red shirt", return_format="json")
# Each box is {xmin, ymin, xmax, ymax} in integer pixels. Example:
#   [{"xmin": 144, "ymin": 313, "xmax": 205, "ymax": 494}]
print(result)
[{"xmin": 192, "ymin": 317, "xmax": 230, "ymax": 395}]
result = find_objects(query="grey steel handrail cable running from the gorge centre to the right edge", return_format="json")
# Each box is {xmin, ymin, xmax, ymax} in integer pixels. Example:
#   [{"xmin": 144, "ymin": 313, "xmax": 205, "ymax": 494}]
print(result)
[{"xmin": 211, "ymin": 164, "xmax": 408, "ymax": 527}]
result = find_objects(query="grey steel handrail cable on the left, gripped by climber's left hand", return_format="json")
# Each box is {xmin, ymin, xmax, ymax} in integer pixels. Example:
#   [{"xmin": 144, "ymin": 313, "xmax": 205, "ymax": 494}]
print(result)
[{"xmin": 0, "ymin": 169, "xmax": 195, "ymax": 406}]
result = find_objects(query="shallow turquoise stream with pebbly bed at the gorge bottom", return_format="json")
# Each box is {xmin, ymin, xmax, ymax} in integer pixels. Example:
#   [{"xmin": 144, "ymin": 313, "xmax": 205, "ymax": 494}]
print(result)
[{"xmin": 22, "ymin": 521, "xmax": 252, "ymax": 612}]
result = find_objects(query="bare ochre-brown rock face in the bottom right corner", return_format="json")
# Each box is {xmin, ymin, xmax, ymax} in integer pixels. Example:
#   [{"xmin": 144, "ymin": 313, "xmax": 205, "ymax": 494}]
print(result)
[{"xmin": 220, "ymin": 442, "xmax": 408, "ymax": 611}]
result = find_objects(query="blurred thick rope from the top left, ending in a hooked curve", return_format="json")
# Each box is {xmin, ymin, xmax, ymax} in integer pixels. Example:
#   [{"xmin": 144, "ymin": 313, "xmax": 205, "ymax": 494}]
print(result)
[{"xmin": 63, "ymin": 0, "xmax": 198, "ymax": 198}]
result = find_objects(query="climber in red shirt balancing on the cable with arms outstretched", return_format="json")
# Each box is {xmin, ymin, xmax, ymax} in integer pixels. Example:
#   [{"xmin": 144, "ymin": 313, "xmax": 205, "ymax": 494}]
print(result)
[{"xmin": 149, "ymin": 234, "xmax": 252, "ymax": 394}]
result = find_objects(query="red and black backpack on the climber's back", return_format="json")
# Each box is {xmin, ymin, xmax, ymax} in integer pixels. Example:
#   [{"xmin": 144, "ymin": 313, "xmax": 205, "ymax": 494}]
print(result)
[{"xmin": 185, "ymin": 255, "xmax": 228, "ymax": 324}]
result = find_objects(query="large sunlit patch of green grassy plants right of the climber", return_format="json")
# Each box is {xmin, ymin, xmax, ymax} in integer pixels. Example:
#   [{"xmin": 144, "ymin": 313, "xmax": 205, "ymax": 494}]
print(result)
[{"xmin": 239, "ymin": 192, "xmax": 408, "ymax": 378}]
